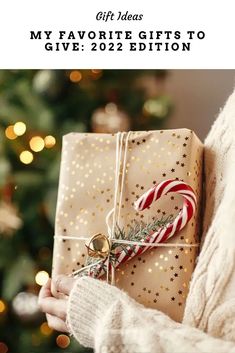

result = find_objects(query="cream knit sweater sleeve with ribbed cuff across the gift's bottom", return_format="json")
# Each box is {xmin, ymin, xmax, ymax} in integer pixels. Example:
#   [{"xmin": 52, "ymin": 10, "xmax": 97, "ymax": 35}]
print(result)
[{"xmin": 67, "ymin": 277, "xmax": 235, "ymax": 353}]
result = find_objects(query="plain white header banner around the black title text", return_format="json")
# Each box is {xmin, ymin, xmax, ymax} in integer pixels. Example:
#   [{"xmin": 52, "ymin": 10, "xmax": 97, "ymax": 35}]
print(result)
[{"xmin": 0, "ymin": 0, "xmax": 235, "ymax": 69}]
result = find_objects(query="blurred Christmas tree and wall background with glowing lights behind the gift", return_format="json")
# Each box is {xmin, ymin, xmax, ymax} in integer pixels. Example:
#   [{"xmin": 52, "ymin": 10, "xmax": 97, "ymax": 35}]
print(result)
[{"xmin": 0, "ymin": 69, "xmax": 235, "ymax": 353}]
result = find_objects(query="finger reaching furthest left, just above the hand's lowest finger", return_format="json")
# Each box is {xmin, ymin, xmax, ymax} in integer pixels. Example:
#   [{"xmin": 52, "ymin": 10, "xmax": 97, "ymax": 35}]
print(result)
[{"xmin": 39, "ymin": 297, "xmax": 67, "ymax": 320}]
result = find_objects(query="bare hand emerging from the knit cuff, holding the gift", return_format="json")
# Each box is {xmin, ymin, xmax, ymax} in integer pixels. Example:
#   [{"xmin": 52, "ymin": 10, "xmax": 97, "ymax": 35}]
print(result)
[{"xmin": 38, "ymin": 275, "xmax": 75, "ymax": 332}]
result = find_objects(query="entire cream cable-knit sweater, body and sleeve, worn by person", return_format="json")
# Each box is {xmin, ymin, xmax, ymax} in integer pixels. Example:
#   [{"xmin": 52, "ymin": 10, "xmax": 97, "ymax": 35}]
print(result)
[{"xmin": 67, "ymin": 92, "xmax": 235, "ymax": 353}]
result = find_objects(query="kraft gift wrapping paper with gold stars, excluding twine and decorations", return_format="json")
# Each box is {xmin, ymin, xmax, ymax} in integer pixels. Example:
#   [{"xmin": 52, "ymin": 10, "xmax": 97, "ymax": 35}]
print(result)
[{"xmin": 52, "ymin": 129, "xmax": 203, "ymax": 322}]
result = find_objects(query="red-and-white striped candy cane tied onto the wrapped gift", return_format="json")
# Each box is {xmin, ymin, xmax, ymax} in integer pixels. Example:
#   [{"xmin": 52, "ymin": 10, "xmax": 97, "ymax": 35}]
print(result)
[{"xmin": 91, "ymin": 179, "xmax": 197, "ymax": 275}]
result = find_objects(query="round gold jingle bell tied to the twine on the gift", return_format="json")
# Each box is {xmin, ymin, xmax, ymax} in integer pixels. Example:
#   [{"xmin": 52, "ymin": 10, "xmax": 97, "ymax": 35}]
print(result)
[{"xmin": 86, "ymin": 233, "xmax": 111, "ymax": 259}]
